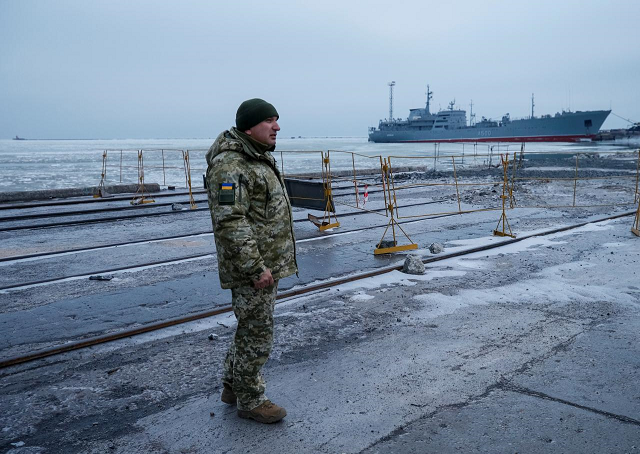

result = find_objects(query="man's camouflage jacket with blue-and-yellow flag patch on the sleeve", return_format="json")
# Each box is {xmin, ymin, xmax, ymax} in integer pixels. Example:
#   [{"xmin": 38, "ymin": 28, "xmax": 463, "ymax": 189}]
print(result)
[{"xmin": 206, "ymin": 128, "xmax": 298, "ymax": 288}]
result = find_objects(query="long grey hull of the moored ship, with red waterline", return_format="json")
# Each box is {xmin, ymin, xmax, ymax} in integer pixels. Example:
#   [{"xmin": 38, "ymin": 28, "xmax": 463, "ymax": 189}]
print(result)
[{"xmin": 369, "ymin": 110, "xmax": 611, "ymax": 143}]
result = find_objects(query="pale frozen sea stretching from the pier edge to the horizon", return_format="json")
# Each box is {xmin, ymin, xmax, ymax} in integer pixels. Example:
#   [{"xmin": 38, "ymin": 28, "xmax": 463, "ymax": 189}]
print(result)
[{"xmin": 0, "ymin": 137, "xmax": 640, "ymax": 192}]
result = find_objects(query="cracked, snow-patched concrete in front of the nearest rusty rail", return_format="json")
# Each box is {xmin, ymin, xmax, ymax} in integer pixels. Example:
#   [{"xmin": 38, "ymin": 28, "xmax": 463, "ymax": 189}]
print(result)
[{"xmin": 0, "ymin": 218, "xmax": 640, "ymax": 454}]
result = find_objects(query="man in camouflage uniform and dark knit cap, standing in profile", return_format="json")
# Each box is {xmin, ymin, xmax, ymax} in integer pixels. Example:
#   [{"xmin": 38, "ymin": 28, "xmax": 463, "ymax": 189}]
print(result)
[{"xmin": 206, "ymin": 98, "xmax": 298, "ymax": 423}]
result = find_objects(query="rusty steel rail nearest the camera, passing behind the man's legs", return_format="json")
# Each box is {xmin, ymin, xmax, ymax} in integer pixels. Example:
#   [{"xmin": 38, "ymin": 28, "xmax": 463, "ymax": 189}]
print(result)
[{"xmin": 0, "ymin": 211, "xmax": 636, "ymax": 369}]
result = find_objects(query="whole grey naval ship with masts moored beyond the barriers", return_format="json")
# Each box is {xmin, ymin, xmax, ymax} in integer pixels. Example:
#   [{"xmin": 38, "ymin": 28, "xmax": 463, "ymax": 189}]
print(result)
[{"xmin": 369, "ymin": 82, "xmax": 611, "ymax": 143}]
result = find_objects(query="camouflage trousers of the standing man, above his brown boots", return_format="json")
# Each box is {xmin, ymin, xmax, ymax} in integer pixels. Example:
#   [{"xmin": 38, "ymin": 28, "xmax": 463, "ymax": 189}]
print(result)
[{"xmin": 222, "ymin": 281, "xmax": 278, "ymax": 410}]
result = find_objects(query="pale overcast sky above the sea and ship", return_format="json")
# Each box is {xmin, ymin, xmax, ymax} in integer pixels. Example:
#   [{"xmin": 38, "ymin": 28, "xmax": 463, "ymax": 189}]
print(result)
[{"xmin": 0, "ymin": 0, "xmax": 640, "ymax": 138}]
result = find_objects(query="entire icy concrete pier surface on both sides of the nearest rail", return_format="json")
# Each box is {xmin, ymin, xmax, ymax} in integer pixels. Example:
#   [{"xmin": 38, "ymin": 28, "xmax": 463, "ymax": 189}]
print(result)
[{"xmin": 0, "ymin": 155, "xmax": 640, "ymax": 454}]
